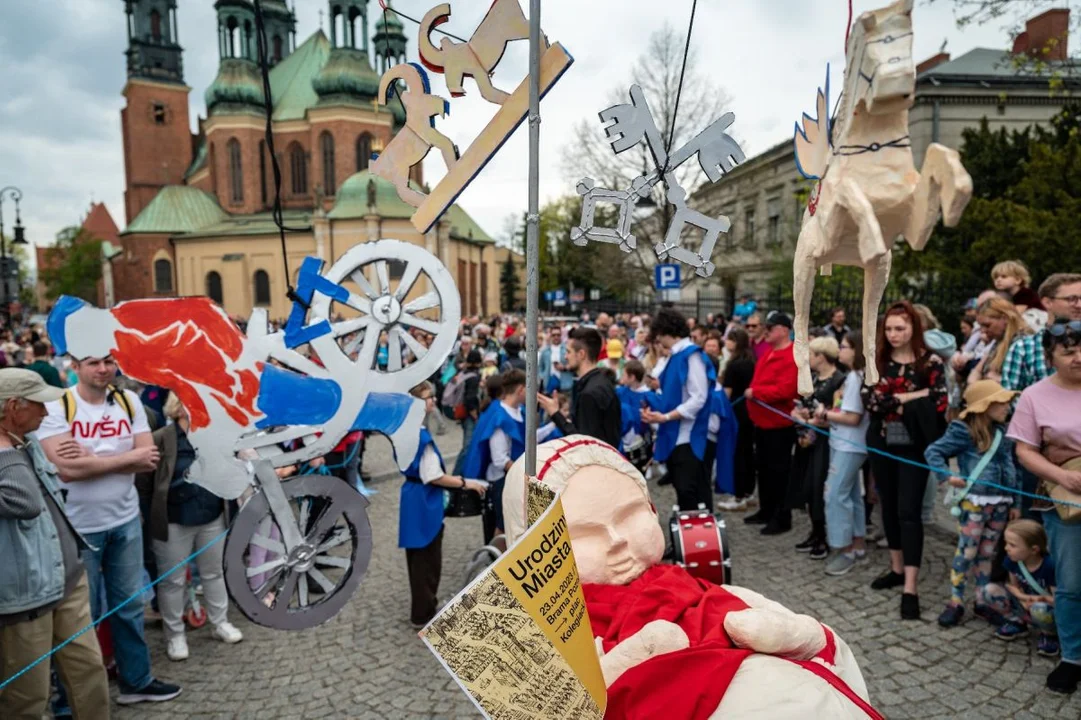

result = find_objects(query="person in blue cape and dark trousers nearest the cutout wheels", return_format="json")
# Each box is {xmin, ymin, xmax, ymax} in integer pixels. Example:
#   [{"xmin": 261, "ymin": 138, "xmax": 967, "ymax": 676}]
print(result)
[{"xmin": 398, "ymin": 382, "xmax": 486, "ymax": 628}]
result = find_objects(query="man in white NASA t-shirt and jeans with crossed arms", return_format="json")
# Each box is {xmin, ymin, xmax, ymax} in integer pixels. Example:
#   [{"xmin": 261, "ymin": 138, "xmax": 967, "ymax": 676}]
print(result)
[{"xmin": 37, "ymin": 358, "xmax": 181, "ymax": 705}]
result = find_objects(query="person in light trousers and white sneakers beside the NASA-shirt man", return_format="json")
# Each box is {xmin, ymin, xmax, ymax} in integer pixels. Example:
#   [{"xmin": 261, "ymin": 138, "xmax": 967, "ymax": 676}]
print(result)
[{"xmin": 137, "ymin": 392, "xmax": 244, "ymax": 661}]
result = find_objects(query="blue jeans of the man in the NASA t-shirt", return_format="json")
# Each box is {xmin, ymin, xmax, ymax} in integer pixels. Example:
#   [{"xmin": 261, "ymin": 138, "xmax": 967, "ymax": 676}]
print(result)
[{"xmin": 82, "ymin": 518, "xmax": 154, "ymax": 692}]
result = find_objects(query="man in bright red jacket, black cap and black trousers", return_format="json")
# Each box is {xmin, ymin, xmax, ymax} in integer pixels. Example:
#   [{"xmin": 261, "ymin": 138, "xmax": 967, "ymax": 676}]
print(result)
[{"xmin": 744, "ymin": 310, "xmax": 799, "ymax": 535}]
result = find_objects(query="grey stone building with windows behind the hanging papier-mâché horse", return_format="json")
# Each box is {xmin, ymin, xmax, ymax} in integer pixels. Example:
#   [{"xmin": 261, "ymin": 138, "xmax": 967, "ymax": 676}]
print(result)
[{"xmin": 683, "ymin": 10, "xmax": 1081, "ymax": 309}]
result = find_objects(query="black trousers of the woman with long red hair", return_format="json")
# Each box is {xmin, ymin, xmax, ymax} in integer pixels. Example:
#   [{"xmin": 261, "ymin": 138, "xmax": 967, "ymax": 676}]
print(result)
[{"xmin": 871, "ymin": 448, "xmax": 927, "ymax": 568}]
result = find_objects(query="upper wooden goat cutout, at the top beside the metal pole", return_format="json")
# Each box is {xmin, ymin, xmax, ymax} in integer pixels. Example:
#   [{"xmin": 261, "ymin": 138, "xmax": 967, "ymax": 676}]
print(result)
[{"xmin": 417, "ymin": 0, "xmax": 534, "ymax": 105}]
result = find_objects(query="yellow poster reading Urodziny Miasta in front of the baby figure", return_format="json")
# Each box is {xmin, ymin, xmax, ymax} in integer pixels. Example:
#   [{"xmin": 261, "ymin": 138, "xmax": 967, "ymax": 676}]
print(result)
[{"xmin": 421, "ymin": 475, "xmax": 606, "ymax": 720}]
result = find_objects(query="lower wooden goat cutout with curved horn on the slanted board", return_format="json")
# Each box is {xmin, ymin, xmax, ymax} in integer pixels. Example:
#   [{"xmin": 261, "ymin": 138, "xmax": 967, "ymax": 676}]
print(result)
[{"xmin": 371, "ymin": 63, "xmax": 458, "ymax": 208}]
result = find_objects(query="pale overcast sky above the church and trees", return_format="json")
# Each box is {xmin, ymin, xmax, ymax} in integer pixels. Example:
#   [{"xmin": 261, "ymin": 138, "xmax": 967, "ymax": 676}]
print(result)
[{"xmin": 0, "ymin": 0, "xmax": 1009, "ymax": 262}]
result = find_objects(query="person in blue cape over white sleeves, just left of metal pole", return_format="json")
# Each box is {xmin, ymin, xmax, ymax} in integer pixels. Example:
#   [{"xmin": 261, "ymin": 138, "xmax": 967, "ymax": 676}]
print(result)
[{"xmin": 462, "ymin": 370, "xmax": 525, "ymax": 544}]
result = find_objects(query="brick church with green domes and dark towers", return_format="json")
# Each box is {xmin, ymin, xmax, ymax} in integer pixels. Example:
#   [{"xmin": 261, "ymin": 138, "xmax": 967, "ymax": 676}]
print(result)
[{"xmin": 112, "ymin": 0, "xmax": 499, "ymax": 319}]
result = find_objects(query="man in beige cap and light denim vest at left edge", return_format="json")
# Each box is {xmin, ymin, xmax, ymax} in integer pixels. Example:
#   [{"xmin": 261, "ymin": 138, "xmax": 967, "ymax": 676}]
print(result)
[{"xmin": 0, "ymin": 369, "xmax": 109, "ymax": 720}]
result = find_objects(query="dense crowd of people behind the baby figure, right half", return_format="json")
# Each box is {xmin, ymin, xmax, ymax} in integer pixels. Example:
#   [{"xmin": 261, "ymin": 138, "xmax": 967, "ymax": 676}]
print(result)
[{"xmin": 432, "ymin": 261, "xmax": 1081, "ymax": 693}]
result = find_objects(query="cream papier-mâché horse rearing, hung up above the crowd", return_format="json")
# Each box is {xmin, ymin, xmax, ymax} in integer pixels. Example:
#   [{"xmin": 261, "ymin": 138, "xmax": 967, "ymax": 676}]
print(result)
[{"xmin": 792, "ymin": 0, "xmax": 972, "ymax": 396}]
